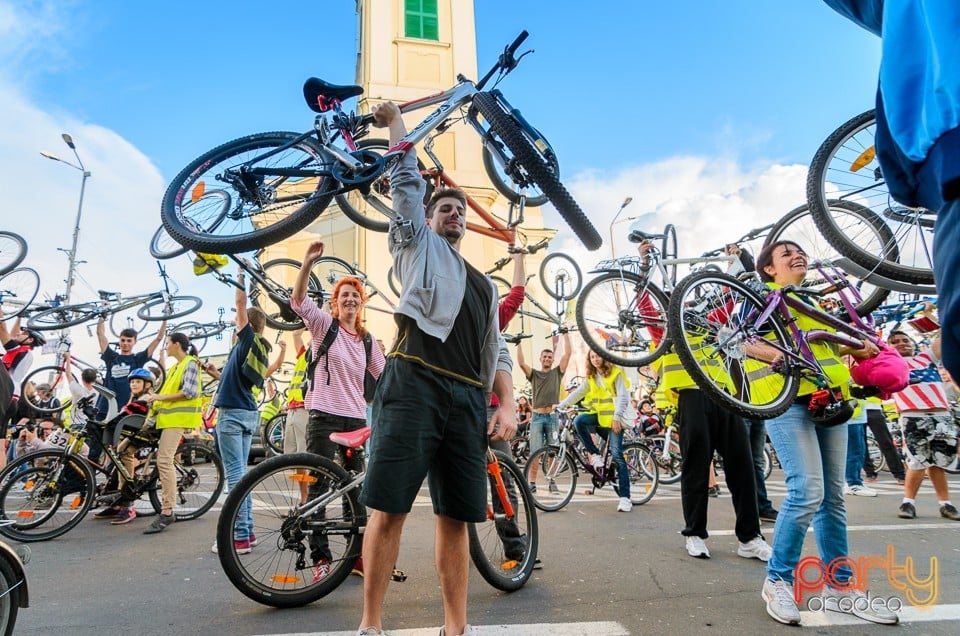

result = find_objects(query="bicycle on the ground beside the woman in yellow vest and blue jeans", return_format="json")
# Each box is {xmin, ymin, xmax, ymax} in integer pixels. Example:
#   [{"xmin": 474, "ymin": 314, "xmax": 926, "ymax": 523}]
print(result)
[{"xmin": 523, "ymin": 411, "xmax": 660, "ymax": 512}]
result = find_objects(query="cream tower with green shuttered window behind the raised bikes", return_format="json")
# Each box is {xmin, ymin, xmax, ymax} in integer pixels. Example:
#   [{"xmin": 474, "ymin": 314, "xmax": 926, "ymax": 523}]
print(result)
[{"xmin": 270, "ymin": 0, "xmax": 568, "ymax": 386}]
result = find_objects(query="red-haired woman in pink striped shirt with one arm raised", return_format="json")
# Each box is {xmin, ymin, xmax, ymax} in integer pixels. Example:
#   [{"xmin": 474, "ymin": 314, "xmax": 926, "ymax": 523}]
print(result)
[{"xmin": 290, "ymin": 241, "xmax": 385, "ymax": 582}]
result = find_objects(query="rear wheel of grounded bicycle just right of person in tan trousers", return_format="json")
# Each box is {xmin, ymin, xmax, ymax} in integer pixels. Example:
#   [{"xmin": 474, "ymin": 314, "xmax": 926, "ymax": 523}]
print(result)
[{"xmin": 149, "ymin": 442, "xmax": 224, "ymax": 521}]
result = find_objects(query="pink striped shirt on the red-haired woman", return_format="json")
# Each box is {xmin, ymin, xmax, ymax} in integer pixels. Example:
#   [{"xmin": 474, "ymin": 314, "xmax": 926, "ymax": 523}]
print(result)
[{"xmin": 290, "ymin": 297, "xmax": 385, "ymax": 419}]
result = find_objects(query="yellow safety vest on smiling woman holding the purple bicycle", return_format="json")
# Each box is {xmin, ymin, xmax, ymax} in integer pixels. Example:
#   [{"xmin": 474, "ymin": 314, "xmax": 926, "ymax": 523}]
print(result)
[{"xmin": 744, "ymin": 283, "xmax": 850, "ymax": 404}]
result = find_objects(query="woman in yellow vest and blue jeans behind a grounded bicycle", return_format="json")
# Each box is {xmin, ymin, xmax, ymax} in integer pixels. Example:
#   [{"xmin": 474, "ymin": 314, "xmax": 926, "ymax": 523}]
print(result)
[{"xmin": 557, "ymin": 350, "xmax": 633, "ymax": 512}]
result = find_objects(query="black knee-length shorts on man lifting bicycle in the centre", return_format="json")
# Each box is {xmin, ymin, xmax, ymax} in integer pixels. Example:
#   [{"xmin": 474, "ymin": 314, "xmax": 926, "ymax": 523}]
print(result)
[{"xmin": 360, "ymin": 358, "xmax": 487, "ymax": 522}]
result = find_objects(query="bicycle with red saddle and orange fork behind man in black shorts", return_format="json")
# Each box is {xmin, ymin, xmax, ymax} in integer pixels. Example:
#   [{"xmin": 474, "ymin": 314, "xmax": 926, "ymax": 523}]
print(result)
[{"xmin": 217, "ymin": 427, "xmax": 539, "ymax": 607}]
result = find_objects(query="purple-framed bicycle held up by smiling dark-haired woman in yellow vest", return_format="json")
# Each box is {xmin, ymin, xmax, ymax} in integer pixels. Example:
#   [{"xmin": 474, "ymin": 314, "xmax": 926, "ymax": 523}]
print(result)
[{"xmin": 668, "ymin": 263, "xmax": 879, "ymax": 419}]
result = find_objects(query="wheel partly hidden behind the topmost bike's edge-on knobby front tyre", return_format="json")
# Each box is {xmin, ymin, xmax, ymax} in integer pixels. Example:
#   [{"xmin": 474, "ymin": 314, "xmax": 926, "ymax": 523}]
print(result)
[{"xmin": 481, "ymin": 121, "xmax": 560, "ymax": 207}]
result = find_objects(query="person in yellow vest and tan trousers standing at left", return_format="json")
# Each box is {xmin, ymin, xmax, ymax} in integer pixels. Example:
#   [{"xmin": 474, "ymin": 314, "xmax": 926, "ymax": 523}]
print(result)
[{"xmin": 143, "ymin": 333, "xmax": 202, "ymax": 534}]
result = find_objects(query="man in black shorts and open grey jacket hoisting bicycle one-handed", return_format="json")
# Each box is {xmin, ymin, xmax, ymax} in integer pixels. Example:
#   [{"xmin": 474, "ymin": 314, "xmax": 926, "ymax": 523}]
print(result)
[{"xmin": 358, "ymin": 102, "xmax": 517, "ymax": 636}]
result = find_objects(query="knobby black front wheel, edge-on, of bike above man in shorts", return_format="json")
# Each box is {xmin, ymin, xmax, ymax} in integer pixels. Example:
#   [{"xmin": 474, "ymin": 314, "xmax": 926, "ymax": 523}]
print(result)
[{"xmin": 473, "ymin": 93, "xmax": 603, "ymax": 251}]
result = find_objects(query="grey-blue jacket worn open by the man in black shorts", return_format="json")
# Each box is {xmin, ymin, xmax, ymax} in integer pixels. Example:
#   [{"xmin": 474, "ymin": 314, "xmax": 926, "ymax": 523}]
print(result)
[{"xmin": 389, "ymin": 149, "xmax": 513, "ymax": 393}]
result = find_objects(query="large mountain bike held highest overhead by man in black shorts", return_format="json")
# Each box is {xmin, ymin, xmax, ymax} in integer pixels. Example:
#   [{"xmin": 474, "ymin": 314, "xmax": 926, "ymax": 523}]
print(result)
[{"xmin": 161, "ymin": 31, "xmax": 603, "ymax": 254}]
